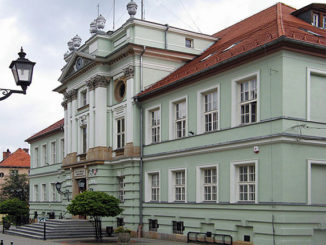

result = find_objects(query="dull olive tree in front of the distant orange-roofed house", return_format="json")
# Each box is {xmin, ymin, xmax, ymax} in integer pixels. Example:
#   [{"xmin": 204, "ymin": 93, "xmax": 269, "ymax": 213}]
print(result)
[{"xmin": 1, "ymin": 174, "xmax": 29, "ymax": 202}]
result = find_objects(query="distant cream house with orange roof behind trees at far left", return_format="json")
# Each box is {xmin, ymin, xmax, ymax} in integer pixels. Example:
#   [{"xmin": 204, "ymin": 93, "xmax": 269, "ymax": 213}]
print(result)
[{"xmin": 0, "ymin": 148, "xmax": 31, "ymax": 189}]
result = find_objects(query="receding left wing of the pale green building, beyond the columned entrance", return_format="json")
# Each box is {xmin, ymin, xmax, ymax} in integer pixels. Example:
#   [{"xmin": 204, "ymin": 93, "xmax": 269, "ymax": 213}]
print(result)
[{"xmin": 26, "ymin": 119, "xmax": 66, "ymax": 218}]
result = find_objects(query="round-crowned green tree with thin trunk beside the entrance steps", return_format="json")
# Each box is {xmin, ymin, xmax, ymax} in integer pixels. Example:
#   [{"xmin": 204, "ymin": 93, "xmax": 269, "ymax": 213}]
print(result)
[{"xmin": 67, "ymin": 191, "xmax": 123, "ymax": 240}]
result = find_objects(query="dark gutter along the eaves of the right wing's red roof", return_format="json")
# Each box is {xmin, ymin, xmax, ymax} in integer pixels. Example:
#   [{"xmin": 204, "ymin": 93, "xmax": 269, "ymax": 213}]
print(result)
[{"xmin": 135, "ymin": 36, "xmax": 326, "ymax": 101}]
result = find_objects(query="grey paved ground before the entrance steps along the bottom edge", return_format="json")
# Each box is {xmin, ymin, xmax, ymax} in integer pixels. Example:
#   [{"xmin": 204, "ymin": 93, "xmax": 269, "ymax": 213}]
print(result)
[{"xmin": 0, "ymin": 234, "xmax": 192, "ymax": 245}]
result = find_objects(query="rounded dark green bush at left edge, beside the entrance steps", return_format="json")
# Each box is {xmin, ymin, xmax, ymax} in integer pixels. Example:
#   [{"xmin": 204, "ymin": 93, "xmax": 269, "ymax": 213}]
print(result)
[{"xmin": 0, "ymin": 198, "xmax": 29, "ymax": 225}]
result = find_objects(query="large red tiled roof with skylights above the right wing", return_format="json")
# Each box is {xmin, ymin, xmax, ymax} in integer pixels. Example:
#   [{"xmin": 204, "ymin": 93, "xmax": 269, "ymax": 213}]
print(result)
[{"xmin": 137, "ymin": 3, "xmax": 326, "ymax": 100}]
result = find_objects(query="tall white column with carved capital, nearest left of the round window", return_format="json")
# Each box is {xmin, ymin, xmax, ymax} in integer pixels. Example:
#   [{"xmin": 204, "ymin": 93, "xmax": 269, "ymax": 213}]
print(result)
[{"xmin": 94, "ymin": 76, "xmax": 108, "ymax": 147}]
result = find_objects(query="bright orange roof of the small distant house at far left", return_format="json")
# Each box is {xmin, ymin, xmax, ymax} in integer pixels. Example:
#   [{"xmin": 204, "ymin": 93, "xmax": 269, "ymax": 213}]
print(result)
[{"xmin": 0, "ymin": 148, "xmax": 31, "ymax": 168}]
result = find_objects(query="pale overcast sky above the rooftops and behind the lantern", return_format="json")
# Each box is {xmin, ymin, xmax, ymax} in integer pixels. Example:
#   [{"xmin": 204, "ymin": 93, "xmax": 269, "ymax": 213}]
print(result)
[{"xmin": 0, "ymin": 0, "xmax": 326, "ymax": 160}]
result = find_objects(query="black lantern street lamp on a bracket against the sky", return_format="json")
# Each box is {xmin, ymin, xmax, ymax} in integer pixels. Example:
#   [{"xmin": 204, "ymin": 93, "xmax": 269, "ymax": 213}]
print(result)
[{"xmin": 0, "ymin": 48, "xmax": 36, "ymax": 101}]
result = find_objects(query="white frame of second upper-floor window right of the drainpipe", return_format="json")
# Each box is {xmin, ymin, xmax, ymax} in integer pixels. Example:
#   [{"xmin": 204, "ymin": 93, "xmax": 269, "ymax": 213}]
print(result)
[{"xmin": 169, "ymin": 96, "xmax": 189, "ymax": 140}]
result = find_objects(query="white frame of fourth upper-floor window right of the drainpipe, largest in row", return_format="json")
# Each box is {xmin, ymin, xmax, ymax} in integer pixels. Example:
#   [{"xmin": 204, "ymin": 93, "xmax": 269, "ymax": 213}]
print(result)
[{"xmin": 231, "ymin": 71, "xmax": 260, "ymax": 127}]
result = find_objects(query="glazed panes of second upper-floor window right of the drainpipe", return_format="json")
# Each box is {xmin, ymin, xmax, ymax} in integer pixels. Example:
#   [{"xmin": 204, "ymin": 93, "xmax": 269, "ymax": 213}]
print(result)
[{"xmin": 175, "ymin": 101, "xmax": 187, "ymax": 138}]
